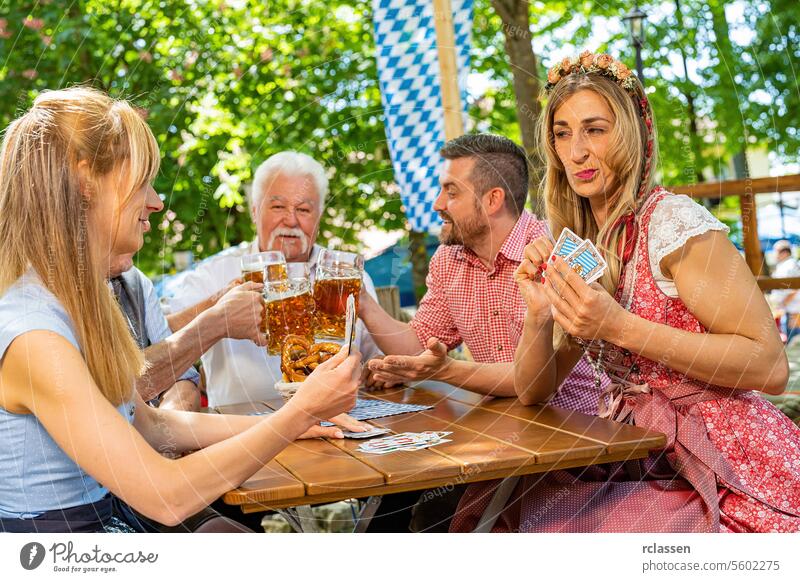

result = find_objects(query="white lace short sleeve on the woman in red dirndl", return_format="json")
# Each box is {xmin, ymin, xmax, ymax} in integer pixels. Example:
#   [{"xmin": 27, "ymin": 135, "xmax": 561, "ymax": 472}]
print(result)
[{"xmin": 647, "ymin": 194, "xmax": 730, "ymax": 281}]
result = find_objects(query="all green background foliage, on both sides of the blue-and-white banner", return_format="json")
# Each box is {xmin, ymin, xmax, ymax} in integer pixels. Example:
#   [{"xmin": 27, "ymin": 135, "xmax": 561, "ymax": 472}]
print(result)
[{"xmin": 0, "ymin": 0, "xmax": 800, "ymax": 274}]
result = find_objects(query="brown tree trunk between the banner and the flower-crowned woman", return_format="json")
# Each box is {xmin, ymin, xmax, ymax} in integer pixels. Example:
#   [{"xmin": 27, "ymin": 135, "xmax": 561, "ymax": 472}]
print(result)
[{"xmin": 492, "ymin": 0, "xmax": 544, "ymax": 217}]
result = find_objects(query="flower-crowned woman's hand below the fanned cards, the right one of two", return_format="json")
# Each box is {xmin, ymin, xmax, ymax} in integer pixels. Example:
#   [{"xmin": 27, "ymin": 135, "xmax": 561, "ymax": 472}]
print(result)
[{"xmin": 542, "ymin": 257, "xmax": 628, "ymax": 342}]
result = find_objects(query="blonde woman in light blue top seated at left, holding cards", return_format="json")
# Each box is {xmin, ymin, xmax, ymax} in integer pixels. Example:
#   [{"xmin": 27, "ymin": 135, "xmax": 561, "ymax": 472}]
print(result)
[{"xmin": 0, "ymin": 88, "xmax": 360, "ymax": 532}]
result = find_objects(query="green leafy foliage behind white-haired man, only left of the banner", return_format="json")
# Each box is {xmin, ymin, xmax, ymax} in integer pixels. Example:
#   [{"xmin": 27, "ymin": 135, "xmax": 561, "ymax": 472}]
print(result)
[{"xmin": 0, "ymin": 0, "xmax": 405, "ymax": 274}]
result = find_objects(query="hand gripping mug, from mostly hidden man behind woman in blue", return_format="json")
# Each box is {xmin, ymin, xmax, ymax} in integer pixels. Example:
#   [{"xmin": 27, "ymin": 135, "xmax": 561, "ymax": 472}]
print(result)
[{"xmin": 211, "ymin": 282, "xmax": 267, "ymax": 346}]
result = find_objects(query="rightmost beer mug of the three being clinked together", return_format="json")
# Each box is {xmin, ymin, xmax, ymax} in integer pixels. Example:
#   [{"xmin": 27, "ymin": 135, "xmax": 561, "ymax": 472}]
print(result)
[{"xmin": 314, "ymin": 249, "xmax": 364, "ymax": 339}]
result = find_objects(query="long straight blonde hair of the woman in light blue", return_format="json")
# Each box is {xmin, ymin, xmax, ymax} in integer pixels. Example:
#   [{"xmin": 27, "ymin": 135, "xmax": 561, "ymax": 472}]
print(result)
[{"xmin": 0, "ymin": 87, "xmax": 159, "ymax": 406}]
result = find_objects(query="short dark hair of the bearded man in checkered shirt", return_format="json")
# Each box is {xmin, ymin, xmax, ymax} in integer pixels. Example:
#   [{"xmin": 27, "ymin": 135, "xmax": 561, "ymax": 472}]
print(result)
[{"xmin": 439, "ymin": 133, "xmax": 528, "ymax": 216}]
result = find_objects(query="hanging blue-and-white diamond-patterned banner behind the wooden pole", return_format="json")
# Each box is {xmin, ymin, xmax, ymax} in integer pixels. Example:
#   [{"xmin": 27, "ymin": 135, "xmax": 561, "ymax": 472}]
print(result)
[{"xmin": 372, "ymin": 0, "xmax": 473, "ymax": 232}]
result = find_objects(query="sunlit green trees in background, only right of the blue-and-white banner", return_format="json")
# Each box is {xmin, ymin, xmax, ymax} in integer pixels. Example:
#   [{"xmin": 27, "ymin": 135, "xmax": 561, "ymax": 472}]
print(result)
[{"xmin": 471, "ymin": 0, "xmax": 800, "ymax": 185}]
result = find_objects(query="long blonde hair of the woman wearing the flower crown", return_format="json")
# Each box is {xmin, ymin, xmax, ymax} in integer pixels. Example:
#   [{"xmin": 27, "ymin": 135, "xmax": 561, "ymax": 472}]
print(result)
[{"xmin": 539, "ymin": 73, "xmax": 658, "ymax": 295}]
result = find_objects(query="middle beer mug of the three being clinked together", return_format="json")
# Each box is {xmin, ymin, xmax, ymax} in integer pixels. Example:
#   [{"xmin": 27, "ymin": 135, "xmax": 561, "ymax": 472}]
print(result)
[{"xmin": 264, "ymin": 263, "xmax": 314, "ymax": 355}]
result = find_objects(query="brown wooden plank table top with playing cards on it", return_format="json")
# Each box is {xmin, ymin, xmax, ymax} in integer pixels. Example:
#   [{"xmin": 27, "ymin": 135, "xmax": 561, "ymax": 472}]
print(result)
[{"xmin": 215, "ymin": 382, "xmax": 666, "ymax": 513}]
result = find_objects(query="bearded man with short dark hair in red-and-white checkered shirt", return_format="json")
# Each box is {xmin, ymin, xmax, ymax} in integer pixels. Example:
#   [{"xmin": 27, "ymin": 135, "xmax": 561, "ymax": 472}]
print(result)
[{"xmin": 359, "ymin": 134, "xmax": 599, "ymax": 414}]
